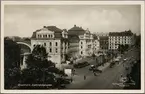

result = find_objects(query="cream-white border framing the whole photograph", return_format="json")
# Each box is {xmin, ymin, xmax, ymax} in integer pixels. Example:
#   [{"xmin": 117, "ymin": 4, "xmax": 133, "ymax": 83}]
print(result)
[{"xmin": 1, "ymin": 1, "xmax": 145, "ymax": 93}]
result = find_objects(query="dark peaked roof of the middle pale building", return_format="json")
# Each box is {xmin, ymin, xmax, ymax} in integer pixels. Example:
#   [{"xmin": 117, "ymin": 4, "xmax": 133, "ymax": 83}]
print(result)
[{"xmin": 68, "ymin": 25, "xmax": 85, "ymax": 35}]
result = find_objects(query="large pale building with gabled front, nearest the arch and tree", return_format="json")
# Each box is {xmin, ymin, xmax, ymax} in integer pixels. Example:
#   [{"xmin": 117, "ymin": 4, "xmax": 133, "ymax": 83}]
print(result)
[{"xmin": 31, "ymin": 26, "xmax": 68, "ymax": 66}]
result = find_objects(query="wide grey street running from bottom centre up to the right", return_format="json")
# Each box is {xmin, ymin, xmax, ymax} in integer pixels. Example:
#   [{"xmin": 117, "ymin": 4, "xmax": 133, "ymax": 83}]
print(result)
[{"xmin": 67, "ymin": 48, "xmax": 139, "ymax": 89}]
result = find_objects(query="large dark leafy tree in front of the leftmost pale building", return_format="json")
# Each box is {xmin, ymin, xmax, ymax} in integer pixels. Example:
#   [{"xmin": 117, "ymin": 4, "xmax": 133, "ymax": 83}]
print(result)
[{"xmin": 20, "ymin": 45, "xmax": 65, "ymax": 89}]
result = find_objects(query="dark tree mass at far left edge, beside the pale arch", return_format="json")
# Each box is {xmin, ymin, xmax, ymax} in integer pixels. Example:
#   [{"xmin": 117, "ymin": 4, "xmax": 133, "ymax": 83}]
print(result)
[{"xmin": 4, "ymin": 38, "xmax": 20, "ymax": 89}]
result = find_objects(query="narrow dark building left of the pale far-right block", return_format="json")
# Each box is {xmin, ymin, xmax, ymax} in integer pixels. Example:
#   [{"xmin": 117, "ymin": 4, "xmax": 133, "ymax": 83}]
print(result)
[{"xmin": 99, "ymin": 36, "xmax": 109, "ymax": 52}]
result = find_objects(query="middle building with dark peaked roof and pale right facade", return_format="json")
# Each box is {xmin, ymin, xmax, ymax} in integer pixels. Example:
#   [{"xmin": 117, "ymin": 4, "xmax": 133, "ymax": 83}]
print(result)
[{"xmin": 68, "ymin": 25, "xmax": 93, "ymax": 58}]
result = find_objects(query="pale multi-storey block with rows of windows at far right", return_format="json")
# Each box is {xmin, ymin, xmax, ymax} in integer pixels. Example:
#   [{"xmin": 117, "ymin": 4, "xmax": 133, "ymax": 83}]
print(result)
[{"xmin": 109, "ymin": 30, "xmax": 134, "ymax": 50}]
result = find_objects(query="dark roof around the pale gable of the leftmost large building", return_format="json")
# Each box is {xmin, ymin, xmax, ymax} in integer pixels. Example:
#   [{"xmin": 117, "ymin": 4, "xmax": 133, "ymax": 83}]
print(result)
[{"xmin": 31, "ymin": 26, "xmax": 63, "ymax": 38}]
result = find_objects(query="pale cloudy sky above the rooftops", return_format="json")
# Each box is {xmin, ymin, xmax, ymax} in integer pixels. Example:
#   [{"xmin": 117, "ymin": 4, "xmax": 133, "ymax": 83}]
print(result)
[{"xmin": 4, "ymin": 5, "xmax": 141, "ymax": 37}]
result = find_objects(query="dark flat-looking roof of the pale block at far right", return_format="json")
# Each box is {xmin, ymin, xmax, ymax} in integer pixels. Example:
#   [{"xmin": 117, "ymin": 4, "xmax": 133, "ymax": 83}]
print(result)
[{"xmin": 109, "ymin": 30, "xmax": 133, "ymax": 36}]
